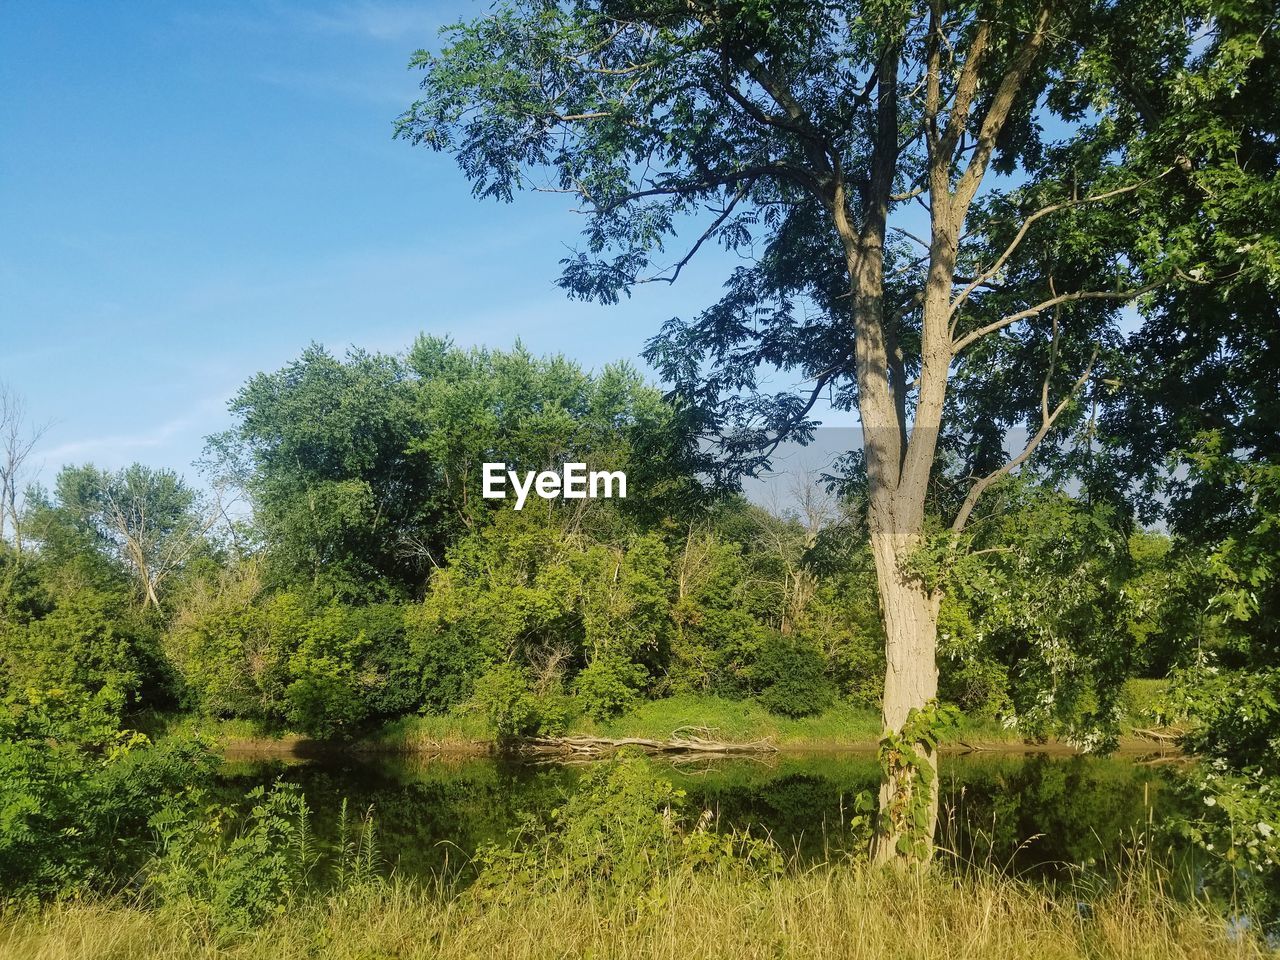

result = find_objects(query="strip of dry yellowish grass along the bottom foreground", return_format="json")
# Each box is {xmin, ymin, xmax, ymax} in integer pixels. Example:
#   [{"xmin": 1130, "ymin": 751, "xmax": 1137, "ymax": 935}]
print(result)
[{"xmin": 0, "ymin": 867, "xmax": 1267, "ymax": 960}]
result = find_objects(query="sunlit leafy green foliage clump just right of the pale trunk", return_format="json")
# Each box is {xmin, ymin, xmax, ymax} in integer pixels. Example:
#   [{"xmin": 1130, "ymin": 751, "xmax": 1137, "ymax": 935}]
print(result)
[{"xmin": 936, "ymin": 481, "xmax": 1133, "ymax": 748}]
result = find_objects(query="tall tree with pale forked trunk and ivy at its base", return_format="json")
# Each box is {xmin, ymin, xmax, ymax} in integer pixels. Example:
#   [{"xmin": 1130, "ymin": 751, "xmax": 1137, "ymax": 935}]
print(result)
[{"xmin": 399, "ymin": 0, "xmax": 1268, "ymax": 859}]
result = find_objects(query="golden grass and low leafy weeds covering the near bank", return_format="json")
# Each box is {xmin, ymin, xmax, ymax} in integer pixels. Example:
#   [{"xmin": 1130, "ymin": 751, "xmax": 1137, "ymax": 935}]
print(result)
[{"xmin": 0, "ymin": 754, "xmax": 1266, "ymax": 960}]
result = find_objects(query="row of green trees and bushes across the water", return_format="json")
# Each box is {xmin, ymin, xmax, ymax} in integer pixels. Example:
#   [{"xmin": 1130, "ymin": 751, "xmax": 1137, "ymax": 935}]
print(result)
[{"xmin": 0, "ymin": 337, "xmax": 1193, "ymax": 737}]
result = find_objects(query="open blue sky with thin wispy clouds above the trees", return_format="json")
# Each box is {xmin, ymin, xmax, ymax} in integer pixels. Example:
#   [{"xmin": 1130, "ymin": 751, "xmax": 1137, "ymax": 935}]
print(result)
[{"xmin": 0, "ymin": 0, "xmax": 783, "ymax": 481}]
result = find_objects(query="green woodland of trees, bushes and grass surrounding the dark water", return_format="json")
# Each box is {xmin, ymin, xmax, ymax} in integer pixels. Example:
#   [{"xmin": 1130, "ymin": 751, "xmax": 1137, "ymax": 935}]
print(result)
[{"xmin": 0, "ymin": 0, "xmax": 1280, "ymax": 957}]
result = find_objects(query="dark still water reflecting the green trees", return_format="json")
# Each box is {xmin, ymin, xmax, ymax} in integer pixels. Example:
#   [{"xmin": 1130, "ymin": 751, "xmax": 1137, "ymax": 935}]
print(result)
[{"xmin": 220, "ymin": 753, "xmax": 1178, "ymax": 877}]
